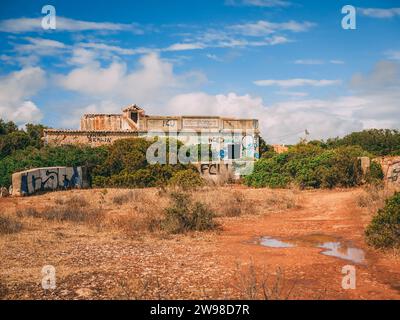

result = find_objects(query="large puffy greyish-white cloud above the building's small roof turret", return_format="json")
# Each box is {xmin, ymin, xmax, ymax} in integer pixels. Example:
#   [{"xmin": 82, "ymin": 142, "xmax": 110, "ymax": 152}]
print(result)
[{"xmin": 58, "ymin": 53, "xmax": 205, "ymax": 104}]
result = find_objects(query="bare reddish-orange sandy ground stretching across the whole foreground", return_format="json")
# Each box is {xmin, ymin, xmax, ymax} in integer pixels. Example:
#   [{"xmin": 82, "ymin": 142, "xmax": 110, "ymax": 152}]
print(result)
[{"xmin": 0, "ymin": 186, "xmax": 400, "ymax": 299}]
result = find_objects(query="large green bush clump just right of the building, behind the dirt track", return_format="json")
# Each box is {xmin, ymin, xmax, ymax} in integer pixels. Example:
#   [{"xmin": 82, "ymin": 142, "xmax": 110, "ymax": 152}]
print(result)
[{"xmin": 245, "ymin": 144, "xmax": 374, "ymax": 188}]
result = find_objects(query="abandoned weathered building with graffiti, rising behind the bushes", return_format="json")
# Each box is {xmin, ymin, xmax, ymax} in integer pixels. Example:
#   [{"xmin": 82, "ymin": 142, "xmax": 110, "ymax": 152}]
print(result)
[{"xmin": 44, "ymin": 105, "xmax": 259, "ymax": 160}]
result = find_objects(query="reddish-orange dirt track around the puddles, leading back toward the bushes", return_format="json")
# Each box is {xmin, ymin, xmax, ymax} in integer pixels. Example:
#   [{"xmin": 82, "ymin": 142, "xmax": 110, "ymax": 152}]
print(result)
[{"xmin": 218, "ymin": 190, "xmax": 400, "ymax": 299}]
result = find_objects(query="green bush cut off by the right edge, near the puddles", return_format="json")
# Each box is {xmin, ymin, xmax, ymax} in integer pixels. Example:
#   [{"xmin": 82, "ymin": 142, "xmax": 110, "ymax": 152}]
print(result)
[{"xmin": 365, "ymin": 192, "xmax": 400, "ymax": 248}]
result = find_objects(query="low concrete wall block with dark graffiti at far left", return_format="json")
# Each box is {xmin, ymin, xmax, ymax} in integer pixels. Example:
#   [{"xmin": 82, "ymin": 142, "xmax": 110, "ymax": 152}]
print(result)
[{"xmin": 12, "ymin": 167, "xmax": 89, "ymax": 196}]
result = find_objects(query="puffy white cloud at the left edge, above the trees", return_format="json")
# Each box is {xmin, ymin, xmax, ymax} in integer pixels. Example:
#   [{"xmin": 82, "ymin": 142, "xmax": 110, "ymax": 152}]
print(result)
[{"xmin": 0, "ymin": 68, "xmax": 45, "ymax": 124}]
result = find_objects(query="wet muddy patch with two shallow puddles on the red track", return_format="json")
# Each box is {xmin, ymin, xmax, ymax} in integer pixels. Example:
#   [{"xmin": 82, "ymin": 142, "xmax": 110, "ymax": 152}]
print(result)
[{"xmin": 259, "ymin": 234, "xmax": 365, "ymax": 263}]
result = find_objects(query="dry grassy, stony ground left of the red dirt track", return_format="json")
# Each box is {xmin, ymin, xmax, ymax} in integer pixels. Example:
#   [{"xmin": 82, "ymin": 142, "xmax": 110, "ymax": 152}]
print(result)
[{"xmin": 0, "ymin": 186, "xmax": 300, "ymax": 299}]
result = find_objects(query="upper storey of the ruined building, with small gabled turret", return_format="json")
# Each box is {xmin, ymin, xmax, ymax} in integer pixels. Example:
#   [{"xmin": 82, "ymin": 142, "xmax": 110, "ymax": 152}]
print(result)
[{"xmin": 80, "ymin": 105, "xmax": 258, "ymax": 132}]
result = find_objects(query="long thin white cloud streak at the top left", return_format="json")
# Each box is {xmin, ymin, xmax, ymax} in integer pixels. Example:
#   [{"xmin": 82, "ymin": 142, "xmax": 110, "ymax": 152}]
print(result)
[{"xmin": 0, "ymin": 16, "xmax": 143, "ymax": 34}]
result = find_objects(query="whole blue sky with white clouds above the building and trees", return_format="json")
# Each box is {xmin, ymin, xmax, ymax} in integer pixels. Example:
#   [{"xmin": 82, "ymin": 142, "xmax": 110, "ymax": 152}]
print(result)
[{"xmin": 0, "ymin": 0, "xmax": 400, "ymax": 143}]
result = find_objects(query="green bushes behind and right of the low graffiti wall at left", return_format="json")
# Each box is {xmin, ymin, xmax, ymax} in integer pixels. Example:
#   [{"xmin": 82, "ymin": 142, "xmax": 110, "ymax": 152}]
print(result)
[{"xmin": 0, "ymin": 134, "xmax": 201, "ymax": 188}]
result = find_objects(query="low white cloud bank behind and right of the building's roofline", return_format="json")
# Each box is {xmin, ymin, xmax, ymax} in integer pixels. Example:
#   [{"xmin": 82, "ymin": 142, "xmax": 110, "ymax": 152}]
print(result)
[{"xmin": 167, "ymin": 92, "xmax": 362, "ymax": 143}]
